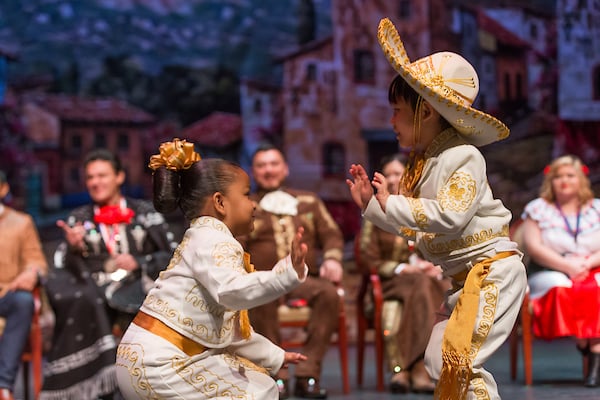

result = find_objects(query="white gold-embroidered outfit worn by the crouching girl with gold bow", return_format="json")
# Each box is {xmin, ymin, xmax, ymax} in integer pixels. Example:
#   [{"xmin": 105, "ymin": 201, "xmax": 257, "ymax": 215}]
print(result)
[{"xmin": 116, "ymin": 217, "xmax": 308, "ymax": 400}]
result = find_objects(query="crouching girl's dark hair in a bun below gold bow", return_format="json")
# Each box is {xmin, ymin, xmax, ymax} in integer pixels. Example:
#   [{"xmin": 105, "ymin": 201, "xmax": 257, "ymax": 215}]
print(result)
[{"xmin": 152, "ymin": 158, "xmax": 241, "ymax": 221}]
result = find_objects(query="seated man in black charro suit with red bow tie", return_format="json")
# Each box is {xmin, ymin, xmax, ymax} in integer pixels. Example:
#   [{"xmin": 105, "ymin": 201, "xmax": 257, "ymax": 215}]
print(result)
[{"xmin": 41, "ymin": 149, "xmax": 174, "ymax": 400}]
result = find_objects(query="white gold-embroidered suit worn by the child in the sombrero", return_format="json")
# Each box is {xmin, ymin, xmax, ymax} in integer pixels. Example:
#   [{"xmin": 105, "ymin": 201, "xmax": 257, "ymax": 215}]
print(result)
[{"xmin": 364, "ymin": 128, "xmax": 527, "ymax": 399}]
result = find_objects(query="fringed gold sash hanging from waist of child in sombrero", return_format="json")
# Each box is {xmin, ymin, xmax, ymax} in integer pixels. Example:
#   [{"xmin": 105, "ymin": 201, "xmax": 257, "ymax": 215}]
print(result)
[{"xmin": 434, "ymin": 251, "xmax": 518, "ymax": 400}]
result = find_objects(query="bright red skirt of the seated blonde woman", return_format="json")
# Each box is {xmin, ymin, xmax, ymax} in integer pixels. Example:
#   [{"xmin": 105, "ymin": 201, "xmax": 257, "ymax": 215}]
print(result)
[{"xmin": 531, "ymin": 268, "xmax": 600, "ymax": 339}]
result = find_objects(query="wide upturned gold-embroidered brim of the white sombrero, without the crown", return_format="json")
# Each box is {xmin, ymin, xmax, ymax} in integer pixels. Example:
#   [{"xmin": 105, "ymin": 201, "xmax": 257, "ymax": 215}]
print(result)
[{"xmin": 377, "ymin": 18, "xmax": 510, "ymax": 146}]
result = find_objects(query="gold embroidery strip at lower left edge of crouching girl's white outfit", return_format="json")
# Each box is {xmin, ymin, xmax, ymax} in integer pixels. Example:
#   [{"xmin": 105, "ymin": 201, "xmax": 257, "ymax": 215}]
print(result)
[{"xmin": 115, "ymin": 342, "xmax": 161, "ymax": 400}]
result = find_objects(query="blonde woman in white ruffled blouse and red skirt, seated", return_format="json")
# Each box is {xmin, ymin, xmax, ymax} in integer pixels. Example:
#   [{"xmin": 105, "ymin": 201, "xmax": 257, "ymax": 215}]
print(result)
[{"xmin": 523, "ymin": 155, "xmax": 600, "ymax": 387}]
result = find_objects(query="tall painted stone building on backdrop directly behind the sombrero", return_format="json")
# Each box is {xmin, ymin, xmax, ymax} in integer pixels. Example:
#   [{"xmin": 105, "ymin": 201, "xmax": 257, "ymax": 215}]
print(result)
[{"xmin": 281, "ymin": 1, "xmax": 458, "ymax": 201}]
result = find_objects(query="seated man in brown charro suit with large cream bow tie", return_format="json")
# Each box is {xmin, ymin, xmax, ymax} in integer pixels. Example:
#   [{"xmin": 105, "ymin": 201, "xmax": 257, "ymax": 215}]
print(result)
[{"xmin": 240, "ymin": 145, "xmax": 344, "ymax": 399}]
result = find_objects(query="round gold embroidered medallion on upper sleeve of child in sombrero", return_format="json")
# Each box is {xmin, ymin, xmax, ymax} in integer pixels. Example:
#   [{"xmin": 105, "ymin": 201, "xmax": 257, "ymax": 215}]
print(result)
[{"xmin": 437, "ymin": 171, "xmax": 477, "ymax": 213}]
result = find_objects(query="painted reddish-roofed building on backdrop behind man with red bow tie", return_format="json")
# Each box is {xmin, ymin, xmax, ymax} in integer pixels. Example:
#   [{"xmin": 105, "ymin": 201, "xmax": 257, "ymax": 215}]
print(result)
[{"xmin": 23, "ymin": 94, "xmax": 155, "ymax": 208}]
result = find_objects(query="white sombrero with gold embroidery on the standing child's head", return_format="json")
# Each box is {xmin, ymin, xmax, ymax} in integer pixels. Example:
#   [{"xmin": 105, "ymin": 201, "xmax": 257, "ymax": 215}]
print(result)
[{"xmin": 377, "ymin": 18, "xmax": 510, "ymax": 146}]
